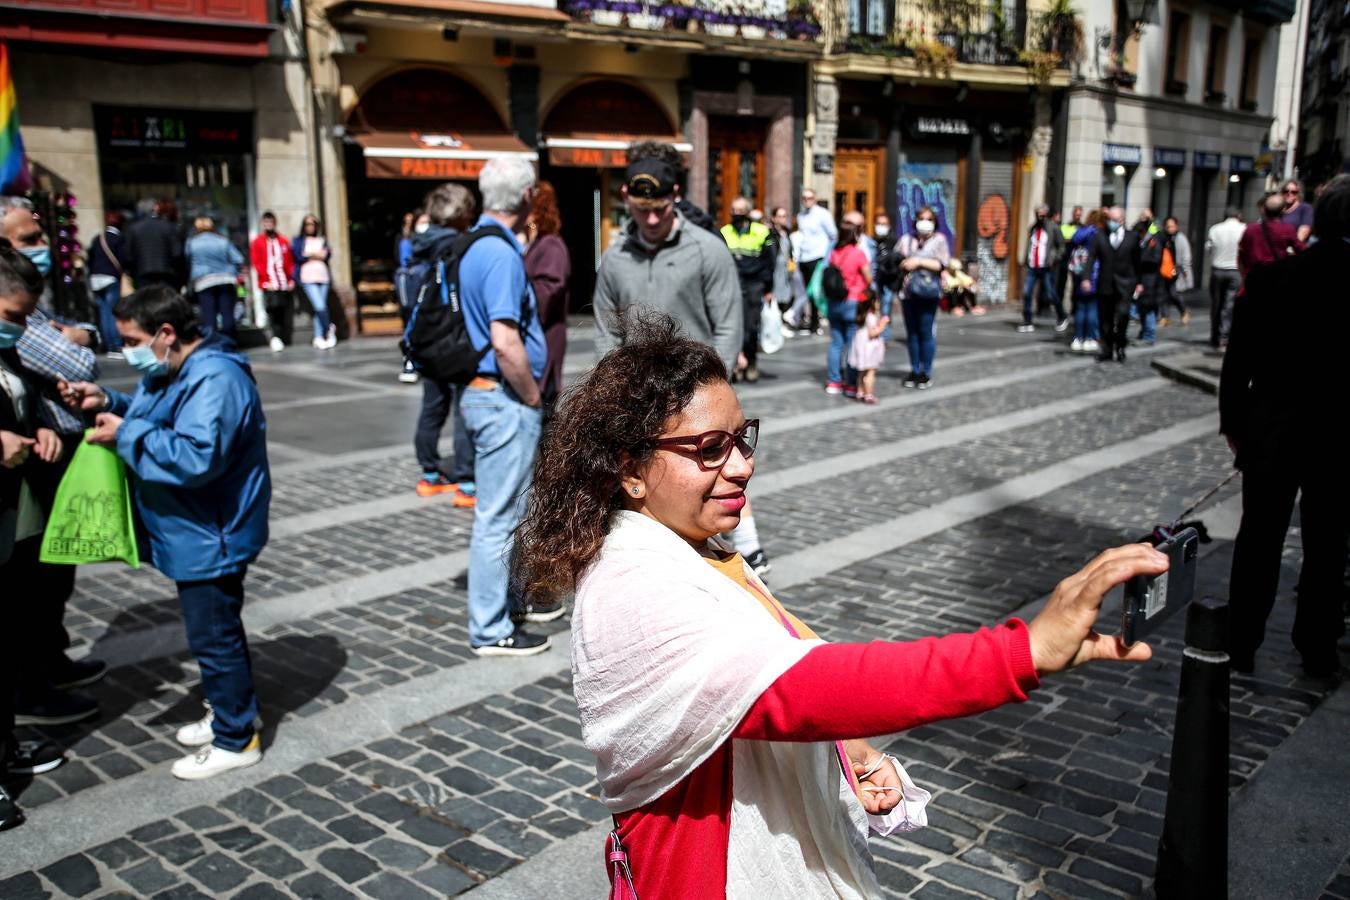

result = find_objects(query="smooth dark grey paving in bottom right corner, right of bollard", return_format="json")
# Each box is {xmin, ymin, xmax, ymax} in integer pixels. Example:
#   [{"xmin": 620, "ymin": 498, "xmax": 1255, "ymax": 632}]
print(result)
[{"xmin": 1229, "ymin": 669, "xmax": 1350, "ymax": 897}]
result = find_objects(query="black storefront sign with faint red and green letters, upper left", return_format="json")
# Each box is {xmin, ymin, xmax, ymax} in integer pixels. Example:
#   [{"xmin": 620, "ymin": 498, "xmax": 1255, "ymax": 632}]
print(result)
[{"xmin": 95, "ymin": 107, "xmax": 252, "ymax": 155}]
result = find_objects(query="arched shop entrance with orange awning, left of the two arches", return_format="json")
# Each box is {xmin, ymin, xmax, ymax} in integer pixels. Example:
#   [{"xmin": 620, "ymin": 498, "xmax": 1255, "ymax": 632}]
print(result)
[{"xmin": 346, "ymin": 66, "xmax": 537, "ymax": 333}]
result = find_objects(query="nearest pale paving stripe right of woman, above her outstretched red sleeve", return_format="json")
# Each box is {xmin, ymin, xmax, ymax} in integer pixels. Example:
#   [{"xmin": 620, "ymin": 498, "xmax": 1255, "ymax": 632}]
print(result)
[{"xmin": 771, "ymin": 414, "xmax": 1219, "ymax": 590}]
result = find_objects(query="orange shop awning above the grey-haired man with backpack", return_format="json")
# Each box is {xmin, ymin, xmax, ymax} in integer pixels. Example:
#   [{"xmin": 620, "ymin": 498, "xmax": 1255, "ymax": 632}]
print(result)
[{"xmin": 352, "ymin": 131, "xmax": 539, "ymax": 181}]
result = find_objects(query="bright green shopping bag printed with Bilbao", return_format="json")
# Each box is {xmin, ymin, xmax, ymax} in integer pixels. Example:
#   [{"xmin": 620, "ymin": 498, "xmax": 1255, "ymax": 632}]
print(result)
[{"xmin": 41, "ymin": 429, "xmax": 140, "ymax": 568}]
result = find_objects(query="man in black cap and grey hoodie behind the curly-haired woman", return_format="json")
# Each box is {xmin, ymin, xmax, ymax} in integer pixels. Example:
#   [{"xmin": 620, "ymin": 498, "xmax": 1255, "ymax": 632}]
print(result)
[{"xmin": 595, "ymin": 159, "xmax": 744, "ymax": 372}]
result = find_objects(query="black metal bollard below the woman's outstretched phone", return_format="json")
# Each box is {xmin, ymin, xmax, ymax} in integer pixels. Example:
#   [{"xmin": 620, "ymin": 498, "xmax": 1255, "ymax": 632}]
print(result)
[{"xmin": 1154, "ymin": 596, "xmax": 1229, "ymax": 900}]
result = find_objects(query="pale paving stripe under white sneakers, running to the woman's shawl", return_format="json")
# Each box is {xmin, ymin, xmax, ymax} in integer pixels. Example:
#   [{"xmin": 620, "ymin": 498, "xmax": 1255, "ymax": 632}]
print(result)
[{"xmin": 0, "ymin": 636, "xmax": 570, "ymax": 878}]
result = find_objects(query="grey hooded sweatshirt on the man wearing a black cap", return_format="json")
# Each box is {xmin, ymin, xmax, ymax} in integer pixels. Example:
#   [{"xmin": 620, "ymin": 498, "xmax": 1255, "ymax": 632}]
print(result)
[{"xmin": 595, "ymin": 213, "xmax": 745, "ymax": 372}]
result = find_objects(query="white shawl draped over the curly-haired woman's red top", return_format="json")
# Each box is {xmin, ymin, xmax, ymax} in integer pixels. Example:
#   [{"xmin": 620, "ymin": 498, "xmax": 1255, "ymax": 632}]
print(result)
[{"xmin": 572, "ymin": 511, "xmax": 882, "ymax": 900}]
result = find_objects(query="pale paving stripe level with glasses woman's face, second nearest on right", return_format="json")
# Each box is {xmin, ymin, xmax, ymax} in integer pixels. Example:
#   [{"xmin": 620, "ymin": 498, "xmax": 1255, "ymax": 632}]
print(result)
[{"xmin": 751, "ymin": 376, "xmax": 1165, "ymax": 498}]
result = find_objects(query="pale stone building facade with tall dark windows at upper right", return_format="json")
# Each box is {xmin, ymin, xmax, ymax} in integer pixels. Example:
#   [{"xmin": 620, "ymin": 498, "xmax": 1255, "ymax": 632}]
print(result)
[{"xmin": 1057, "ymin": 0, "xmax": 1295, "ymax": 273}]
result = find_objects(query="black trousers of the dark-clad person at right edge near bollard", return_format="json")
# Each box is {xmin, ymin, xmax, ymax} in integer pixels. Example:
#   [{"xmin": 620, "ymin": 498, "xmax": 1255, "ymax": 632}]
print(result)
[{"xmin": 1229, "ymin": 460, "xmax": 1350, "ymax": 656}]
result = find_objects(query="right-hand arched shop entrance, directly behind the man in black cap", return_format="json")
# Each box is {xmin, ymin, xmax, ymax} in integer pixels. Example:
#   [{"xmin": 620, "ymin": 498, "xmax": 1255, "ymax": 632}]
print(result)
[{"xmin": 540, "ymin": 78, "xmax": 690, "ymax": 309}]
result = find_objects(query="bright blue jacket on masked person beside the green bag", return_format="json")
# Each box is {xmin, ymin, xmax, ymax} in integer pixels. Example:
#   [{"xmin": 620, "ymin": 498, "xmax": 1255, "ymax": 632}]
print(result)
[{"xmin": 108, "ymin": 335, "xmax": 271, "ymax": 582}]
